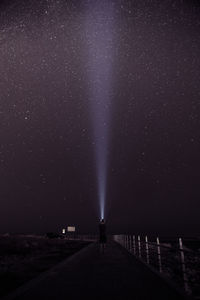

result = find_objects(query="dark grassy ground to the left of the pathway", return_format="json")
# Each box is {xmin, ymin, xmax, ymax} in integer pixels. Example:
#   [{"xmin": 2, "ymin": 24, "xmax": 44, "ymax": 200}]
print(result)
[{"xmin": 0, "ymin": 235, "xmax": 88, "ymax": 297}]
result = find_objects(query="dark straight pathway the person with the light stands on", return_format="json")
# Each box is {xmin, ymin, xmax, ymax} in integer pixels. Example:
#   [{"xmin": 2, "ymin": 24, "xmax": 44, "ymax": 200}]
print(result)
[{"xmin": 3, "ymin": 242, "xmax": 187, "ymax": 300}]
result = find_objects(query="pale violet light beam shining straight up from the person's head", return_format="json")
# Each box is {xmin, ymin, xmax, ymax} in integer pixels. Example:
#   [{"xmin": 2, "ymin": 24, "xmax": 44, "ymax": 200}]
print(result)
[{"xmin": 86, "ymin": 0, "xmax": 114, "ymax": 218}]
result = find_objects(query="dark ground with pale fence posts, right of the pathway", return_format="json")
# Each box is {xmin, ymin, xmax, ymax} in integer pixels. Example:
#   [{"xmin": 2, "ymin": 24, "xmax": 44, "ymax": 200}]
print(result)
[{"xmin": 114, "ymin": 235, "xmax": 200, "ymax": 299}]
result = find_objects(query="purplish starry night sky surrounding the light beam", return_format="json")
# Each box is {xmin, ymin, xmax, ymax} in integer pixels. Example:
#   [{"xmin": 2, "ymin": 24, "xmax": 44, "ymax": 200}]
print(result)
[{"xmin": 0, "ymin": 0, "xmax": 200, "ymax": 234}]
